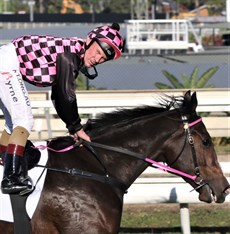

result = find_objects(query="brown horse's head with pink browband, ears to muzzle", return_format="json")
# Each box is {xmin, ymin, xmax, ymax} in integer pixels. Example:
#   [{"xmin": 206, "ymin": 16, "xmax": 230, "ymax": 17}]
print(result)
[{"xmin": 162, "ymin": 91, "xmax": 230, "ymax": 203}]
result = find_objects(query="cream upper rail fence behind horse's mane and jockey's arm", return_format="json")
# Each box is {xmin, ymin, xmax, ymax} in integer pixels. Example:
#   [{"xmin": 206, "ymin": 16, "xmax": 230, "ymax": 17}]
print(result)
[{"xmin": 0, "ymin": 89, "xmax": 230, "ymax": 140}]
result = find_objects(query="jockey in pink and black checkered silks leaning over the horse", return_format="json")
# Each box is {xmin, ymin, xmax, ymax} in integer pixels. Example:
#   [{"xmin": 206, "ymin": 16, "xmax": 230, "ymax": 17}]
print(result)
[{"xmin": 0, "ymin": 23, "xmax": 123, "ymax": 194}]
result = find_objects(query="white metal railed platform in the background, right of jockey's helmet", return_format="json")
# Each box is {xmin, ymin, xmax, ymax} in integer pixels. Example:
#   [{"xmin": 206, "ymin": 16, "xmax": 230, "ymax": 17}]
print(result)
[{"xmin": 126, "ymin": 20, "xmax": 204, "ymax": 53}]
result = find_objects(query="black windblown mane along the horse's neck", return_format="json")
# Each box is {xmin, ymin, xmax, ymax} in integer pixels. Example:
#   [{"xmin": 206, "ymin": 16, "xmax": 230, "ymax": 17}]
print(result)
[{"xmin": 86, "ymin": 95, "xmax": 184, "ymax": 133}]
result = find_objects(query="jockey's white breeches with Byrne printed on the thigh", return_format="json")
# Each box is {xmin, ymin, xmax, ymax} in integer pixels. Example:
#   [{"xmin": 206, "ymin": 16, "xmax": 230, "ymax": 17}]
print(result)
[{"xmin": 0, "ymin": 43, "xmax": 33, "ymax": 134}]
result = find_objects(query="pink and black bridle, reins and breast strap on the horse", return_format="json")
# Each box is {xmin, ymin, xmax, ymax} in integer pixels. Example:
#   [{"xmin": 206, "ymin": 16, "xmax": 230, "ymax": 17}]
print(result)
[{"xmin": 36, "ymin": 116, "xmax": 207, "ymax": 191}]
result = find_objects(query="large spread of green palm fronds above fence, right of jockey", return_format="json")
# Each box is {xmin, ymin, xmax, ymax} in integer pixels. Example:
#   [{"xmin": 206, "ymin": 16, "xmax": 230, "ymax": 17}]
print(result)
[{"xmin": 155, "ymin": 67, "xmax": 219, "ymax": 89}]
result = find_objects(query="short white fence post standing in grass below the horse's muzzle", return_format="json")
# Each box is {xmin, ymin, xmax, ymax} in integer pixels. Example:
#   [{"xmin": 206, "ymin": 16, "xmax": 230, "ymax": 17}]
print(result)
[{"xmin": 180, "ymin": 203, "xmax": 191, "ymax": 234}]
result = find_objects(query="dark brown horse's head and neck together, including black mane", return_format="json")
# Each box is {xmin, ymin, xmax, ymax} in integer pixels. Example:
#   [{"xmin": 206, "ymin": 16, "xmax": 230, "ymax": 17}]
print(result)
[{"xmin": 83, "ymin": 91, "xmax": 230, "ymax": 203}]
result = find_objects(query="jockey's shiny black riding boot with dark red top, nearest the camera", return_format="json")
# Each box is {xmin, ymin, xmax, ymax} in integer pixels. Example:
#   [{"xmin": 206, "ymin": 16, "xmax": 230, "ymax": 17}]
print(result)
[{"xmin": 1, "ymin": 144, "xmax": 32, "ymax": 194}]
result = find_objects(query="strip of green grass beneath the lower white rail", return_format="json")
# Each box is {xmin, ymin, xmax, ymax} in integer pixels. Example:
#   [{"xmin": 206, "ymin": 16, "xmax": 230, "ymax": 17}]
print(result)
[{"xmin": 120, "ymin": 203, "xmax": 230, "ymax": 234}]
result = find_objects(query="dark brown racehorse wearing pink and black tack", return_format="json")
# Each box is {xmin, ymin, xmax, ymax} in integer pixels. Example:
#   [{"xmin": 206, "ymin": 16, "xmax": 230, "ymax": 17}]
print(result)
[{"xmin": 0, "ymin": 91, "xmax": 230, "ymax": 234}]
